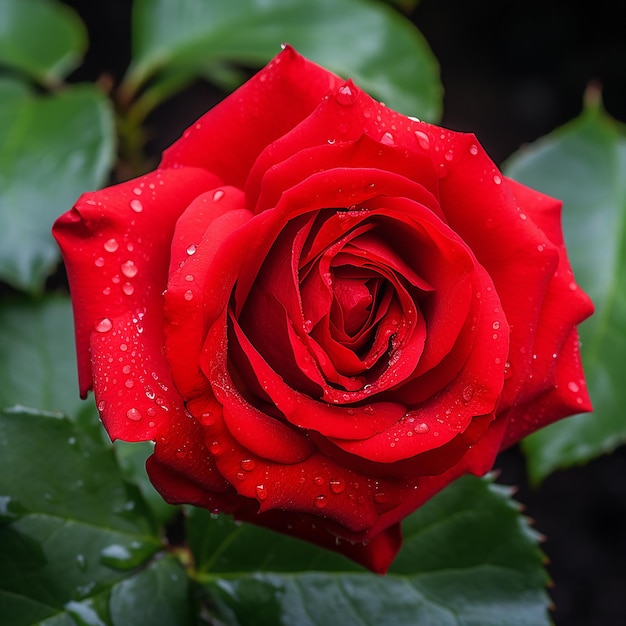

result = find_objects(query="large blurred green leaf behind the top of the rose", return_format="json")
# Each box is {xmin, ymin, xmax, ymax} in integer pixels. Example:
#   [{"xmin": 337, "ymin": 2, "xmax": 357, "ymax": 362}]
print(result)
[{"xmin": 125, "ymin": 0, "xmax": 442, "ymax": 121}]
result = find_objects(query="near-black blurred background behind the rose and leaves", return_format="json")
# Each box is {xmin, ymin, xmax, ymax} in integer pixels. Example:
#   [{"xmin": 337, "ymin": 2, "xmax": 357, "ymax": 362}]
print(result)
[{"xmin": 59, "ymin": 0, "xmax": 626, "ymax": 626}]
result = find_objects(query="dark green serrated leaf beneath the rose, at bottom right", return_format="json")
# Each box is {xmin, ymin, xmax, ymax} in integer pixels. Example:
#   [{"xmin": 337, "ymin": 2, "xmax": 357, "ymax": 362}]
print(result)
[{"xmin": 194, "ymin": 477, "xmax": 550, "ymax": 626}]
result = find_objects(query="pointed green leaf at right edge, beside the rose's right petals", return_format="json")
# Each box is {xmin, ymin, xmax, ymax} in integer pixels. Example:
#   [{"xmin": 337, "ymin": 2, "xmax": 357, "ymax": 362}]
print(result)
[{"xmin": 506, "ymin": 95, "xmax": 626, "ymax": 482}]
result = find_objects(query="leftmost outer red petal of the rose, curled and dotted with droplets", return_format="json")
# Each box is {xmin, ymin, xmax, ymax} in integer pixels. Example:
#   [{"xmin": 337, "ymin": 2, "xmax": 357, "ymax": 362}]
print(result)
[{"xmin": 53, "ymin": 168, "xmax": 219, "ymax": 440}]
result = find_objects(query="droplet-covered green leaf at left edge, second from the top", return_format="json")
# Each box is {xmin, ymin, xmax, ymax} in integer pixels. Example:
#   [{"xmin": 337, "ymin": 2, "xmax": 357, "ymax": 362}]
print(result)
[{"xmin": 0, "ymin": 80, "xmax": 114, "ymax": 292}]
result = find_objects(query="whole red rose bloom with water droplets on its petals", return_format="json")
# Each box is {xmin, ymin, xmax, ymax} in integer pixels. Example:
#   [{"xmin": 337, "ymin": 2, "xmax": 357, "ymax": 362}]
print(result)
[{"xmin": 54, "ymin": 48, "xmax": 592, "ymax": 573}]
